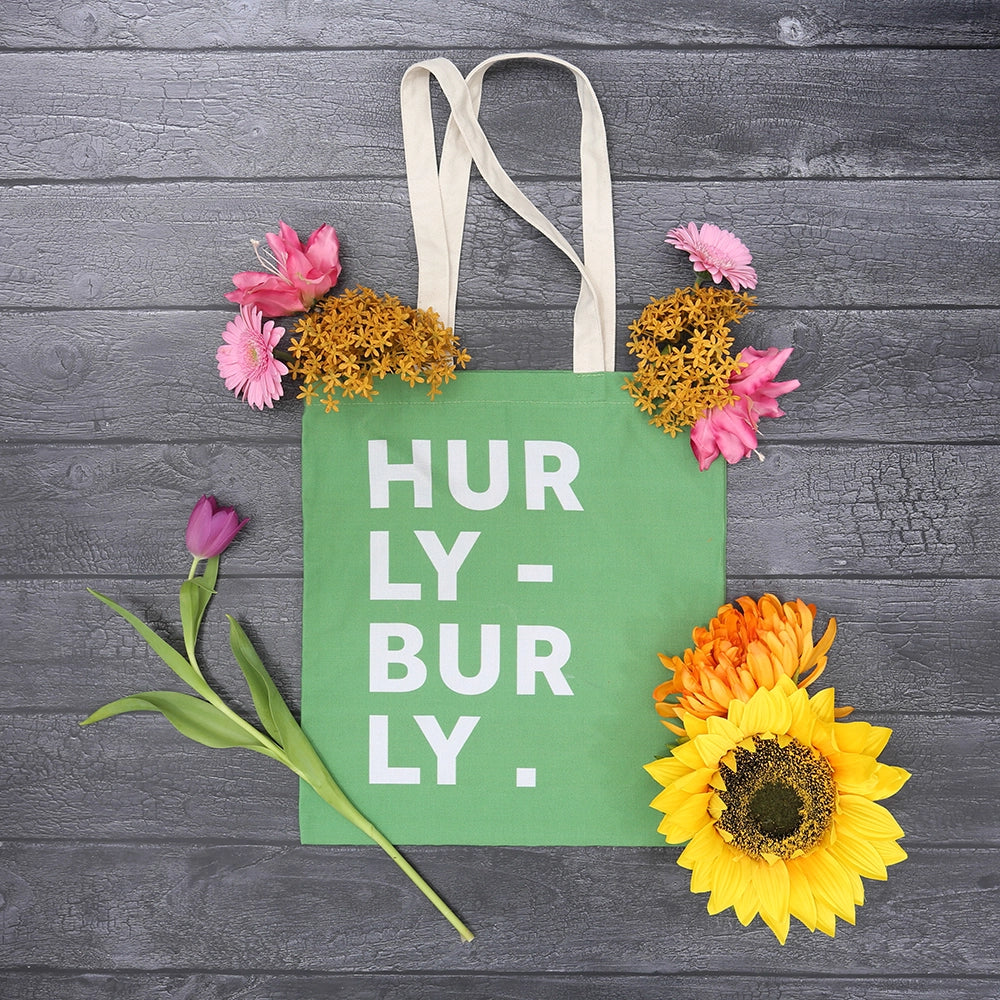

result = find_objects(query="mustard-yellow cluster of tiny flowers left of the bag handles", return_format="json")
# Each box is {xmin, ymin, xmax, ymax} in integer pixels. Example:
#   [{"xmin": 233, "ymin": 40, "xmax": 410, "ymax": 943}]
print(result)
[{"xmin": 289, "ymin": 287, "xmax": 469, "ymax": 412}]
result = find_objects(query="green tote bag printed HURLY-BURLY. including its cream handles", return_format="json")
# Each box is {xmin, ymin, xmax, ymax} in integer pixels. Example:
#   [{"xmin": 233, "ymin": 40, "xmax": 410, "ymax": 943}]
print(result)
[{"xmin": 300, "ymin": 53, "xmax": 726, "ymax": 845}]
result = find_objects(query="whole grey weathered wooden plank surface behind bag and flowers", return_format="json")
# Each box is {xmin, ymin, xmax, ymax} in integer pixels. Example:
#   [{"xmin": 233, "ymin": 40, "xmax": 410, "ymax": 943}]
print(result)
[{"xmin": 0, "ymin": 0, "xmax": 1000, "ymax": 1000}]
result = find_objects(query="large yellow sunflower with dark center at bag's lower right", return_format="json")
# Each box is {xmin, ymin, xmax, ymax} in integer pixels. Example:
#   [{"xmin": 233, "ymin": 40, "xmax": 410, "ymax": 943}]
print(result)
[{"xmin": 646, "ymin": 677, "xmax": 910, "ymax": 944}]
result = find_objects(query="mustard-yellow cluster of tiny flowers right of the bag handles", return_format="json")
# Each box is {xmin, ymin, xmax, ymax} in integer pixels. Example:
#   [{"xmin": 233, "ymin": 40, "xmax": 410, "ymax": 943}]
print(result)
[{"xmin": 622, "ymin": 285, "xmax": 754, "ymax": 437}]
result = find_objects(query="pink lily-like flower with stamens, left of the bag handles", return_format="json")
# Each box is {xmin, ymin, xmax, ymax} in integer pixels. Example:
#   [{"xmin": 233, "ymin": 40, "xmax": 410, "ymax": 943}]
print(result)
[{"xmin": 226, "ymin": 222, "xmax": 340, "ymax": 318}]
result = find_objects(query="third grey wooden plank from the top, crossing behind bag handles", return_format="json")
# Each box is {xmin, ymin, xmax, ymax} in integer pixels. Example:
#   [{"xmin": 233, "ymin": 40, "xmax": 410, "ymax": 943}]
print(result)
[{"xmin": 0, "ymin": 178, "xmax": 1000, "ymax": 308}]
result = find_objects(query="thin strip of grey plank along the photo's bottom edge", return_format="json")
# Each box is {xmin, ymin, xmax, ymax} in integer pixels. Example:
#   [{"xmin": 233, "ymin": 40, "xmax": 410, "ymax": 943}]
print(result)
[{"xmin": 0, "ymin": 970, "xmax": 997, "ymax": 1000}]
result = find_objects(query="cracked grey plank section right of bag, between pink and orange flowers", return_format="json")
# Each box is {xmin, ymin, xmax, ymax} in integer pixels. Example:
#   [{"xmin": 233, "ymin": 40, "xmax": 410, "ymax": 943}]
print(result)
[{"xmin": 726, "ymin": 440, "xmax": 1000, "ymax": 576}]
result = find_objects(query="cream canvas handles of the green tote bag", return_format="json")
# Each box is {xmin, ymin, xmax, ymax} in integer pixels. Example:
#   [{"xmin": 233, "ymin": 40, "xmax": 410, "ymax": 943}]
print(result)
[{"xmin": 400, "ymin": 52, "xmax": 615, "ymax": 372}]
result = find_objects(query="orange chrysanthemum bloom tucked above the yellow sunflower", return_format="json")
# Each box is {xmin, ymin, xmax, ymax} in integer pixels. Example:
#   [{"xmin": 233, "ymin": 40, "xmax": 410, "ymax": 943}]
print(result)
[{"xmin": 653, "ymin": 594, "xmax": 851, "ymax": 736}]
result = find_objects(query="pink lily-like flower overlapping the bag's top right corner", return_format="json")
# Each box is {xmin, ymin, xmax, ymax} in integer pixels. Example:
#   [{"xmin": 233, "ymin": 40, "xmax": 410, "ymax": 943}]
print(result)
[{"xmin": 691, "ymin": 347, "xmax": 799, "ymax": 472}]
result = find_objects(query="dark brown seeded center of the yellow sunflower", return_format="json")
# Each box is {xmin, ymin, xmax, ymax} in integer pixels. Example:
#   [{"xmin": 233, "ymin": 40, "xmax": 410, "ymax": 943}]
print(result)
[{"xmin": 717, "ymin": 737, "xmax": 836, "ymax": 858}]
